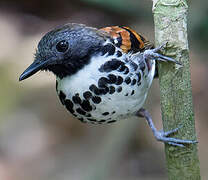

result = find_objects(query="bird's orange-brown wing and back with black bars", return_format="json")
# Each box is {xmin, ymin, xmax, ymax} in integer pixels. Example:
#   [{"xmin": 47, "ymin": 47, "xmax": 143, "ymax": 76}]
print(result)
[{"xmin": 99, "ymin": 26, "xmax": 153, "ymax": 53}]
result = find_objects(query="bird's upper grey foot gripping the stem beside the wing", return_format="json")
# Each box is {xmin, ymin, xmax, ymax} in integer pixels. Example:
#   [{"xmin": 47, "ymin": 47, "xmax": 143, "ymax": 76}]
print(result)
[{"xmin": 143, "ymin": 43, "xmax": 182, "ymax": 66}]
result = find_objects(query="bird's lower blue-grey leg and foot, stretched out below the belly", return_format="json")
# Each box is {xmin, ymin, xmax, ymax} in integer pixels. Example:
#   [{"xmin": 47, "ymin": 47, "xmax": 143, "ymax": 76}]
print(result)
[{"xmin": 136, "ymin": 108, "xmax": 197, "ymax": 147}]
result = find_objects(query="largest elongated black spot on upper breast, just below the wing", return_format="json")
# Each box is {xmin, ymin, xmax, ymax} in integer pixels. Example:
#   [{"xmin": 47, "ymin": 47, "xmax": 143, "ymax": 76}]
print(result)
[{"xmin": 99, "ymin": 59, "xmax": 124, "ymax": 72}]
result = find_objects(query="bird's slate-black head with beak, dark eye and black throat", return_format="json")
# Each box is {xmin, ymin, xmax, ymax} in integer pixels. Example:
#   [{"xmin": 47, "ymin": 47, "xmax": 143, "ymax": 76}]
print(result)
[{"xmin": 19, "ymin": 23, "xmax": 105, "ymax": 81}]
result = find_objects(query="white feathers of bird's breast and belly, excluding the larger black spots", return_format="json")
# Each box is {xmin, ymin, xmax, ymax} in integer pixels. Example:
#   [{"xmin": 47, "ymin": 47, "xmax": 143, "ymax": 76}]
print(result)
[{"xmin": 57, "ymin": 52, "xmax": 155, "ymax": 122}]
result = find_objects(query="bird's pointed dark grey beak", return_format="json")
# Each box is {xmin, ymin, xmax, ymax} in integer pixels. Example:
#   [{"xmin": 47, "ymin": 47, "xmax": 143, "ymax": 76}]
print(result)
[{"xmin": 19, "ymin": 60, "xmax": 48, "ymax": 81}]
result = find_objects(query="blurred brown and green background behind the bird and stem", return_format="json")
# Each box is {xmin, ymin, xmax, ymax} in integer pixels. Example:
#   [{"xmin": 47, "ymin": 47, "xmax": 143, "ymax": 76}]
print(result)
[{"xmin": 0, "ymin": 0, "xmax": 208, "ymax": 180}]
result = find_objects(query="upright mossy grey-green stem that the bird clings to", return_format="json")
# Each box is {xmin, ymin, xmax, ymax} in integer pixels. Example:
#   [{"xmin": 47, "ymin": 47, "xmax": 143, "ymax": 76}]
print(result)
[{"xmin": 153, "ymin": 0, "xmax": 200, "ymax": 180}]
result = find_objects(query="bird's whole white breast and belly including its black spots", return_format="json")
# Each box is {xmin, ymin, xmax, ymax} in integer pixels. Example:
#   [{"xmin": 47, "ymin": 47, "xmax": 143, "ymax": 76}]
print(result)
[{"xmin": 57, "ymin": 54, "xmax": 155, "ymax": 124}]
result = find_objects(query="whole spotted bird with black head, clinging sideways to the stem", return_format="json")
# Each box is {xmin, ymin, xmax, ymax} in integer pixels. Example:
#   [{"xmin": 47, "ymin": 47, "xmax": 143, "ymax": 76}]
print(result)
[{"xmin": 19, "ymin": 23, "xmax": 196, "ymax": 147}]
